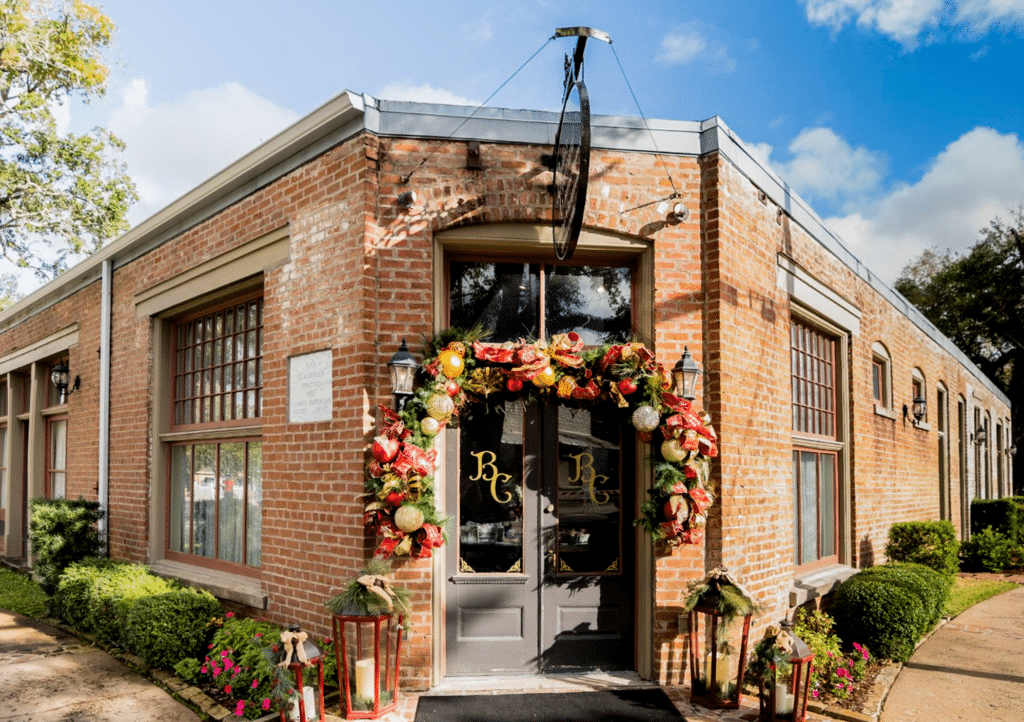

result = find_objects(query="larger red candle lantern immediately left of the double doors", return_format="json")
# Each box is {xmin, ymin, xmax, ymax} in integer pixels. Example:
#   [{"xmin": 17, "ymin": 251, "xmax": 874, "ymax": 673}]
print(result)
[{"xmin": 334, "ymin": 613, "xmax": 402, "ymax": 720}]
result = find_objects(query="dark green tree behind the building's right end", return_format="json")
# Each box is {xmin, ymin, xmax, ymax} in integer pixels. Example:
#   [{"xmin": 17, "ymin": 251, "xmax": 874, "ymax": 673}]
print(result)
[{"xmin": 896, "ymin": 206, "xmax": 1024, "ymax": 494}]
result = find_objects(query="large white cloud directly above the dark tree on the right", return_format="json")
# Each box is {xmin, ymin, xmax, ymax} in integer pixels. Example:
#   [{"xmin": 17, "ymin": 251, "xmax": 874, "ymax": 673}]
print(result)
[{"xmin": 825, "ymin": 128, "xmax": 1024, "ymax": 284}]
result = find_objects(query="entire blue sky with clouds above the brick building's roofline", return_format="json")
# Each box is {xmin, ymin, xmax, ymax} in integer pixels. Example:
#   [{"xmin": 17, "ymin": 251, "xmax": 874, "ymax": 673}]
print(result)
[{"xmin": 32, "ymin": 0, "xmax": 1024, "ymax": 292}]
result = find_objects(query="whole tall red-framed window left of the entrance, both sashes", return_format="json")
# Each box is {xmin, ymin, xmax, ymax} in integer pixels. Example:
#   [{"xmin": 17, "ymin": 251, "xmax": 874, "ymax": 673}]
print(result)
[{"xmin": 167, "ymin": 296, "xmax": 263, "ymax": 574}]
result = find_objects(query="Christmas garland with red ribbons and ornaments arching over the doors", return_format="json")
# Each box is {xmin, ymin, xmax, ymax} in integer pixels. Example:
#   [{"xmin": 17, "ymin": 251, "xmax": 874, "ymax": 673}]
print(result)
[{"xmin": 365, "ymin": 329, "xmax": 718, "ymax": 559}]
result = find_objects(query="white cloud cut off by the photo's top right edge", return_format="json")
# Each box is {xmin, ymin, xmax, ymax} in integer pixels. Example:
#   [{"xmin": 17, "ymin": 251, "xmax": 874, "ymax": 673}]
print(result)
[{"xmin": 802, "ymin": 0, "xmax": 1024, "ymax": 49}]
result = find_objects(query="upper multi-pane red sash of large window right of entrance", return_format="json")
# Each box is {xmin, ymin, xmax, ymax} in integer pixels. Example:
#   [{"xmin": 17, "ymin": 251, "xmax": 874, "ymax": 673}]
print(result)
[{"xmin": 790, "ymin": 318, "xmax": 836, "ymax": 438}]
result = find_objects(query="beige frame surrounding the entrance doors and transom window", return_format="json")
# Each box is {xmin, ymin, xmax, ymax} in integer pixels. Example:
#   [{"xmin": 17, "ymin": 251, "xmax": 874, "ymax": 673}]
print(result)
[{"xmin": 430, "ymin": 223, "xmax": 654, "ymax": 687}]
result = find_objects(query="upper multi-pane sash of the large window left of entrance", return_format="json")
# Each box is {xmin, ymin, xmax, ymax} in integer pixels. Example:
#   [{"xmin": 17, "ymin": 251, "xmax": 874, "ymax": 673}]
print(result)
[{"xmin": 172, "ymin": 298, "xmax": 263, "ymax": 427}]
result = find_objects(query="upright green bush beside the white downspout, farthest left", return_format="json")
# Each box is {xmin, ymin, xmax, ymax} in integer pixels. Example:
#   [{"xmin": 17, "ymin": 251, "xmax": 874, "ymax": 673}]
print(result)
[{"xmin": 29, "ymin": 499, "xmax": 103, "ymax": 595}]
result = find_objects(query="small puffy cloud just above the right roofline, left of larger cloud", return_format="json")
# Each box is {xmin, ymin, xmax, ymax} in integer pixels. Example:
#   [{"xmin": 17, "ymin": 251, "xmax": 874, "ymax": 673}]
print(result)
[{"xmin": 754, "ymin": 128, "xmax": 887, "ymax": 211}]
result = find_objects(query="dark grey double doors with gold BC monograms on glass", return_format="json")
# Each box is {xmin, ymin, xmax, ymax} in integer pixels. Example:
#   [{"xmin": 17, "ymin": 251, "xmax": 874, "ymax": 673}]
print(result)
[{"xmin": 445, "ymin": 401, "xmax": 635, "ymax": 676}]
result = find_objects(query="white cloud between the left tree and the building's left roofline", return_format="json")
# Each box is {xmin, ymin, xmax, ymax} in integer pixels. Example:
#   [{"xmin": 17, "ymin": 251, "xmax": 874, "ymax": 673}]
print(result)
[{"xmin": 108, "ymin": 80, "xmax": 298, "ymax": 225}]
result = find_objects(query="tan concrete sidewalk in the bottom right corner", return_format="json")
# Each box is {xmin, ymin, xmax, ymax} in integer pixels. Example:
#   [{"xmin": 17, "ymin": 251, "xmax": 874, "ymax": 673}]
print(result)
[{"xmin": 881, "ymin": 578, "xmax": 1024, "ymax": 722}]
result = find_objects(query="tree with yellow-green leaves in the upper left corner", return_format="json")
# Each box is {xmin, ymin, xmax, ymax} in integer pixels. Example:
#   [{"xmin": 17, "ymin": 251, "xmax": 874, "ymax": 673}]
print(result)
[{"xmin": 0, "ymin": 0, "xmax": 137, "ymax": 280}]
